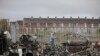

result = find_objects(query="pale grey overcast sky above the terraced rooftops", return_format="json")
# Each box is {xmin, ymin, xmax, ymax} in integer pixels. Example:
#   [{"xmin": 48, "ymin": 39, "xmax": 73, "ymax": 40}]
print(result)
[{"xmin": 0, "ymin": 0, "xmax": 100, "ymax": 20}]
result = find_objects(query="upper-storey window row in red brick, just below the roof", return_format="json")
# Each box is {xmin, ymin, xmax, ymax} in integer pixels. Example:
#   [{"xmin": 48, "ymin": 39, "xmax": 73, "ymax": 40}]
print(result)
[{"xmin": 16, "ymin": 23, "xmax": 100, "ymax": 28}]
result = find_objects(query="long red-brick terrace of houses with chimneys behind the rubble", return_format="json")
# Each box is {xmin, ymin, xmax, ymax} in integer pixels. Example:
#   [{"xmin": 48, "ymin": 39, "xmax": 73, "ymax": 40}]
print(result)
[{"xmin": 16, "ymin": 17, "xmax": 100, "ymax": 34}]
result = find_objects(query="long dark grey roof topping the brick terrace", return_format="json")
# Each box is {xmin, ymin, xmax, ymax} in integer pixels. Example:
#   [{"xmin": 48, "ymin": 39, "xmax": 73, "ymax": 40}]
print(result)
[{"xmin": 24, "ymin": 18, "xmax": 100, "ymax": 24}]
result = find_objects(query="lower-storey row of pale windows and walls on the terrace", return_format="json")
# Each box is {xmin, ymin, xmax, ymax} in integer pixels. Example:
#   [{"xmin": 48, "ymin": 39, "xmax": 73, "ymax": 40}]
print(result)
[{"xmin": 17, "ymin": 28, "xmax": 99, "ymax": 33}]
